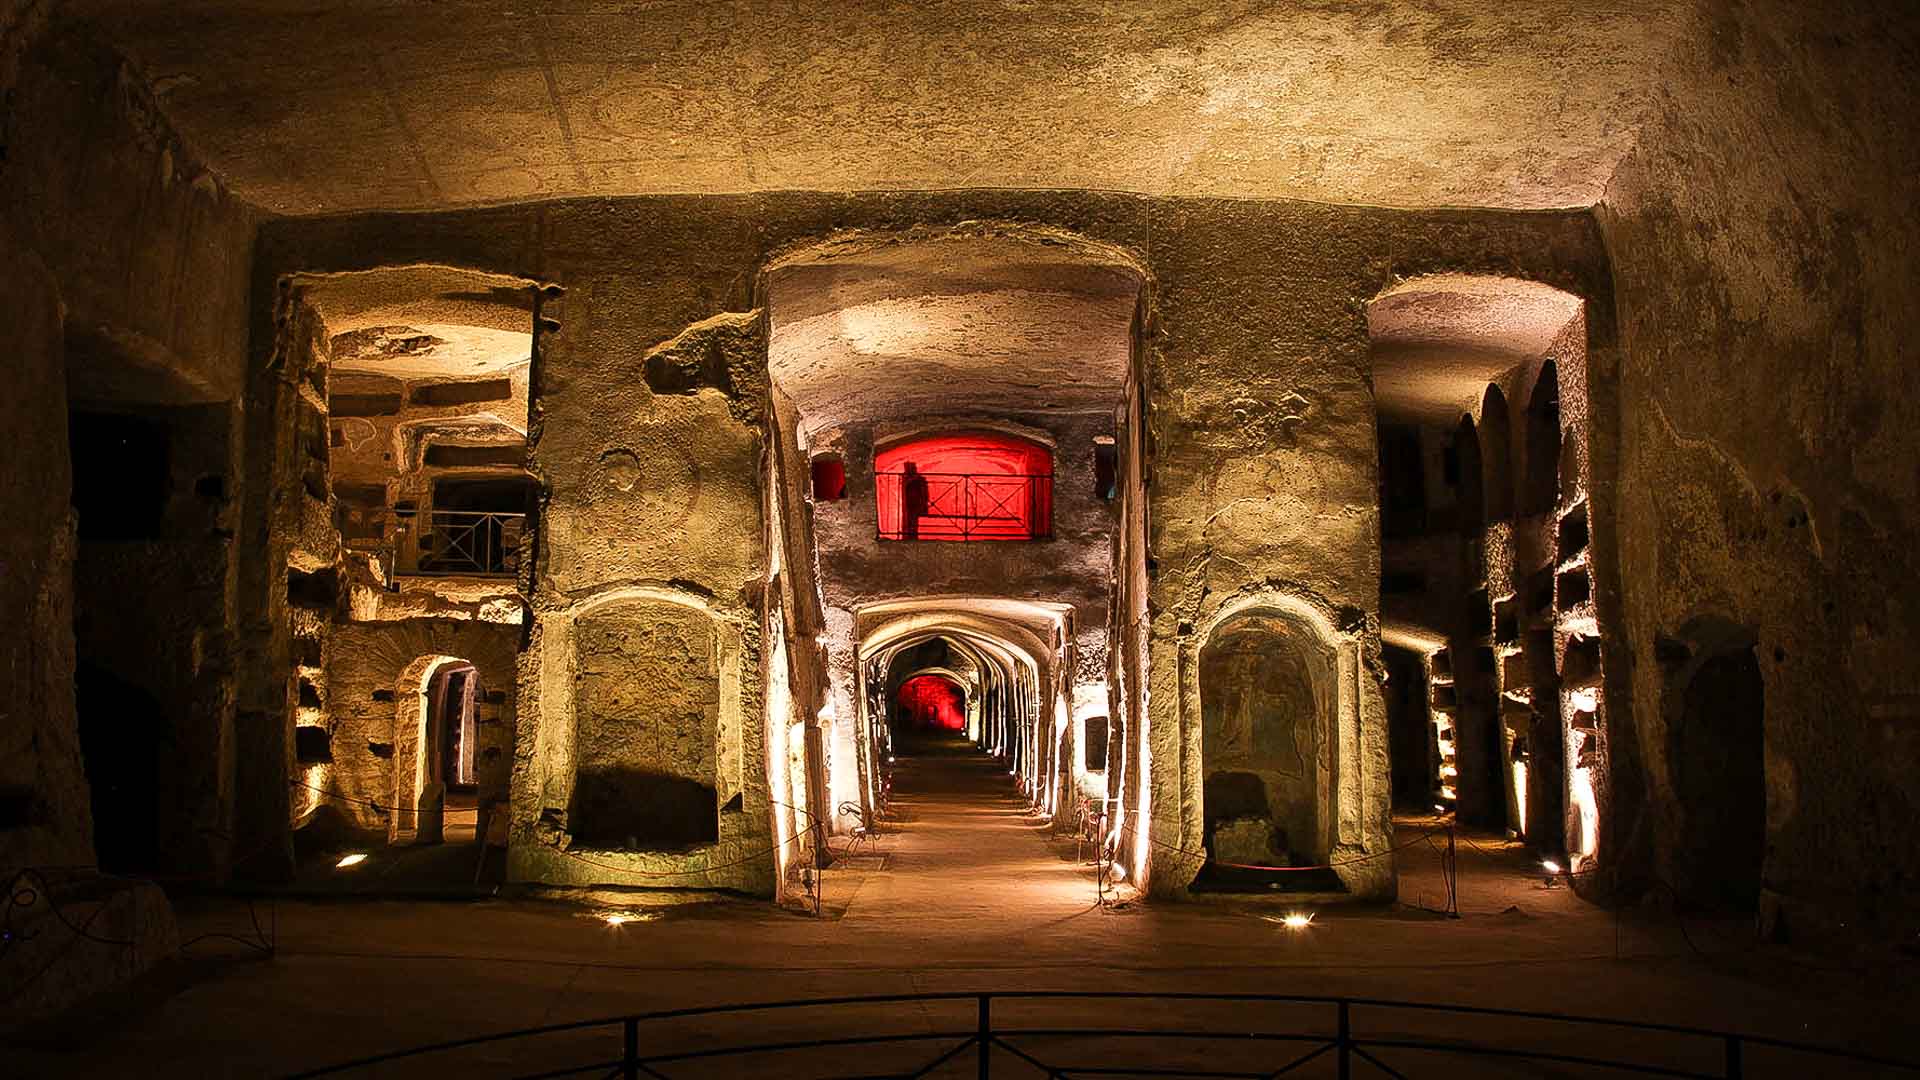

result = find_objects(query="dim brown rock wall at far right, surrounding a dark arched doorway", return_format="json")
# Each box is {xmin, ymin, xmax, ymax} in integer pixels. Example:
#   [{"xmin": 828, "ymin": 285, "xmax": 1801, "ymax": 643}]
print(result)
[{"xmin": 1597, "ymin": 2, "xmax": 1920, "ymax": 934}]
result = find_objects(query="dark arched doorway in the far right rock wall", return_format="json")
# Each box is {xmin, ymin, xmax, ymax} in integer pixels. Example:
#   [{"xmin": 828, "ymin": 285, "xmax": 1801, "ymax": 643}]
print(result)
[{"xmin": 1668, "ymin": 648, "xmax": 1766, "ymax": 911}]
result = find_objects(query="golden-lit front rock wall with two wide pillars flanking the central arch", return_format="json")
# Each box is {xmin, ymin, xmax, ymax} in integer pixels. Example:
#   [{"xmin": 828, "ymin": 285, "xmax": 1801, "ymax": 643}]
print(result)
[{"xmin": 255, "ymin": 192, "xmax": 1607, "ymax": 896}]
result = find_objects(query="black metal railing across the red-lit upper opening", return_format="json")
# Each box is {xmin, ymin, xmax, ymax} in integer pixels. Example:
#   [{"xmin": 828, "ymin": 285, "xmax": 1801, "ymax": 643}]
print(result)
[{"xmin": 874, "ymin": 471, "xmax": 1054, "ymax": 540}]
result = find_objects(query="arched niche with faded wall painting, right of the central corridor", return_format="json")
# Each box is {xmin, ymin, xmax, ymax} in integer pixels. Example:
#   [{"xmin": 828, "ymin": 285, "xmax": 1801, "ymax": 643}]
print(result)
[{"xmin": 1200, "ymin": 613, "xmax": 1329, "ymax": 867}]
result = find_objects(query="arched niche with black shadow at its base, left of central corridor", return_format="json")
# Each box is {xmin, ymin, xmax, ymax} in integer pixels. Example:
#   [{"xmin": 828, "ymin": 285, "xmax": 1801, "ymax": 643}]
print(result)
[{"xmin": 568, "ymin": 601, "xmax": 720, "ymax": 851}]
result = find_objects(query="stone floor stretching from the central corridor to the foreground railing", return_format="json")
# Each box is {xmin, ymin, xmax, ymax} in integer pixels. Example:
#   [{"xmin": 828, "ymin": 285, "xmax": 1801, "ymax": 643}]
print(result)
[{"xmin": 0, "ymin": 737, "xmax": 1920, "ymax": 1078}]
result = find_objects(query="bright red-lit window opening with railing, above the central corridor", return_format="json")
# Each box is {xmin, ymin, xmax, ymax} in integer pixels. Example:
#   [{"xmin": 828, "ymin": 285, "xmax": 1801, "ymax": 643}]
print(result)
[{"xmin": 874, "ymin": 432, "xmax": 1054, "ymax": 540}]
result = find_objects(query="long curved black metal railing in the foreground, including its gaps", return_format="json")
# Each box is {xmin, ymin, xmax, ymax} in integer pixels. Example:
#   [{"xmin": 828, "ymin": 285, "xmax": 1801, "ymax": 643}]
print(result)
[{"xmin": 278, "ymin": 992, "xmax": 1920, "ymax": 1080}]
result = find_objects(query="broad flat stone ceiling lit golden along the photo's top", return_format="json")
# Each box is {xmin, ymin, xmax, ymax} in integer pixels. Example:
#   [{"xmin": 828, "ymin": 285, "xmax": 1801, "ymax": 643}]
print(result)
[{"xmin": 69, "ymin": 0, "xmax": 1692, "ymax": 213}]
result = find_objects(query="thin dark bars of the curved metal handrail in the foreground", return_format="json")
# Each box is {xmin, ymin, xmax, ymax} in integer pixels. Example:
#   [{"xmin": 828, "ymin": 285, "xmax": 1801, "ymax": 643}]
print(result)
[{"xmin": 288, "ymin": 990, "xmax": 1920, "ymax": 1080}]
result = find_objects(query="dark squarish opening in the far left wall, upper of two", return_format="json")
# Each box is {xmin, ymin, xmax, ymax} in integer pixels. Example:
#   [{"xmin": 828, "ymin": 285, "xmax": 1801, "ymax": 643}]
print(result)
[{"xmin": 67, "ymin": 411, "xmax": 171, "ymax": 540}]
